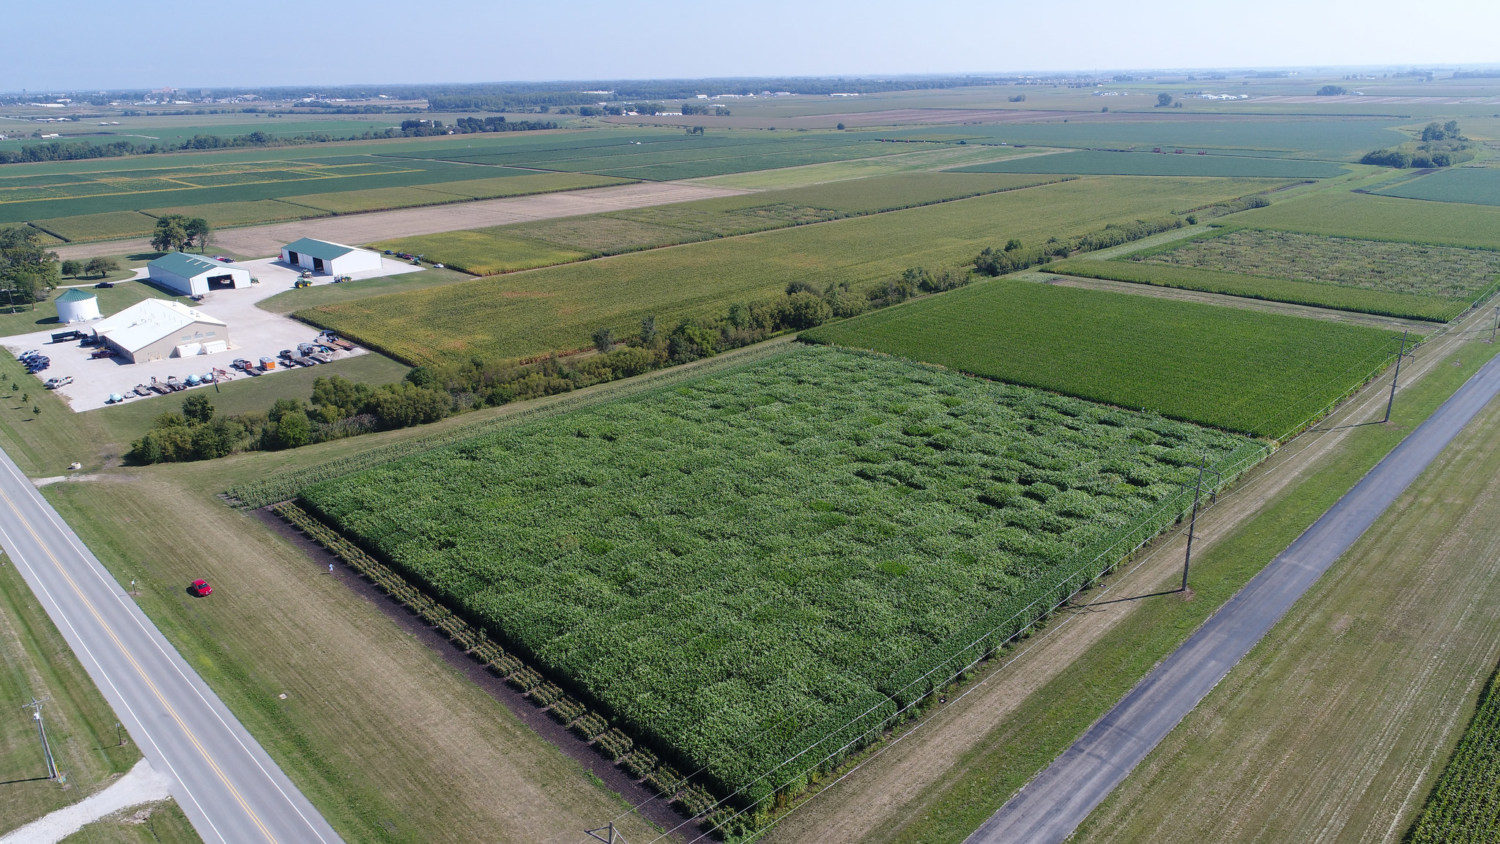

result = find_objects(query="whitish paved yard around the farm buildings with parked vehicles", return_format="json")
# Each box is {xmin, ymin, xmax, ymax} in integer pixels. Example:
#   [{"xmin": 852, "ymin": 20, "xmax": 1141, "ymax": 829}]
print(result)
[{"xmin": 0, "ymin": 258, "xmax": 422, "ymax": 412}]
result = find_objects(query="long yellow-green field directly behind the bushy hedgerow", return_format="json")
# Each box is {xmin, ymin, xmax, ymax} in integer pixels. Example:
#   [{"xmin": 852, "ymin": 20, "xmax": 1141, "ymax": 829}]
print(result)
[{"xmin": 297, "ymin": 177, "xmax": 1263, "ymax": 363}]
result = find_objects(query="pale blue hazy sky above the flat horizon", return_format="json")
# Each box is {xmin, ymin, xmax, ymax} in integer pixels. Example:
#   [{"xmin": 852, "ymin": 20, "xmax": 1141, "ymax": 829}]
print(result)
[{"xmin": 0, "ymin": 0, "xmax": 1500, "ymax": 91}]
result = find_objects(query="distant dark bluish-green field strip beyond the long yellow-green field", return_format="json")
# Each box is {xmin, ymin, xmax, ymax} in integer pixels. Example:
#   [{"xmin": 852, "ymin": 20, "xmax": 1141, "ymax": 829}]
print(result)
[{"xmin": 950, "ymin": 148, "xmax": 1344, "ymax": 178}]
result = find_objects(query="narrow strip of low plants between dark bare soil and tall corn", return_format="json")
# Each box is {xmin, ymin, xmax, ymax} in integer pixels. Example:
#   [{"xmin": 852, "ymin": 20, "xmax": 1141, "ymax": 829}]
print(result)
[{"xmin": 272, "ymin": 502, "xmax": 714, "ymax": 814}]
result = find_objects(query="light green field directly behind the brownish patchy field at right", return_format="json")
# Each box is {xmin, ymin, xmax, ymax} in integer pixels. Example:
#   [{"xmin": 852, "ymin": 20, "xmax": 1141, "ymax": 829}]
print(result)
[{"xmin": 1235, "ymin": 192, "xmax": 1500, "ymax": 249}]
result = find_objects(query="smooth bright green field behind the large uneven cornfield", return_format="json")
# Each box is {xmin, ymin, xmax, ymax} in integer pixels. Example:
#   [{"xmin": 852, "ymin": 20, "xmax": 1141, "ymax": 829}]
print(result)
[{"xmin": 803, "ymin": 279, "xmax": 1400, "ymax": 438}]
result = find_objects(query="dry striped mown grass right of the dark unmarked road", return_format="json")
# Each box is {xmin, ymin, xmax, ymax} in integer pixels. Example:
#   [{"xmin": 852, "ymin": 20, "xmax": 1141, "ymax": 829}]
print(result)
[{"xmin": 1079, "ymin": 386, "xmax": 1500, "ymax": 843}]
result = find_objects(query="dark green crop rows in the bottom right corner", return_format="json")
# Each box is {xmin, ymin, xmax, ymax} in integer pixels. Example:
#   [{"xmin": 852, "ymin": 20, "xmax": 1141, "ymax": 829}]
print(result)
[{"xmin": 1412, "ymin": 662, "xmax": 1500, "ymax": 841}]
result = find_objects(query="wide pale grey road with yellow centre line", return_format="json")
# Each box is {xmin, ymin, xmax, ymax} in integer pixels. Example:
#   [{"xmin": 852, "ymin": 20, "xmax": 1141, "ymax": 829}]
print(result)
[{"xmin": 0, "ymin": 453, "xmax": 339, "ymax": 843}]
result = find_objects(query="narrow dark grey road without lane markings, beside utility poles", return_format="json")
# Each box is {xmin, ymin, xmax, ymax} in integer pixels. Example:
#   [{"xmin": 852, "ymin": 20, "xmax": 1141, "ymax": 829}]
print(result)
[{"xmin": 969, "ymin": 358, "xmax": 1500, "ymax": 843}]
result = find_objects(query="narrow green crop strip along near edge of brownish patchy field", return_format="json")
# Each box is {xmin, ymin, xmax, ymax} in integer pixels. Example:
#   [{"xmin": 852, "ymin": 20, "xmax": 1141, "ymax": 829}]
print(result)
[{"xmin": 1043, "ymin": 258, "xmax": 1469, "ymax": 322}]
